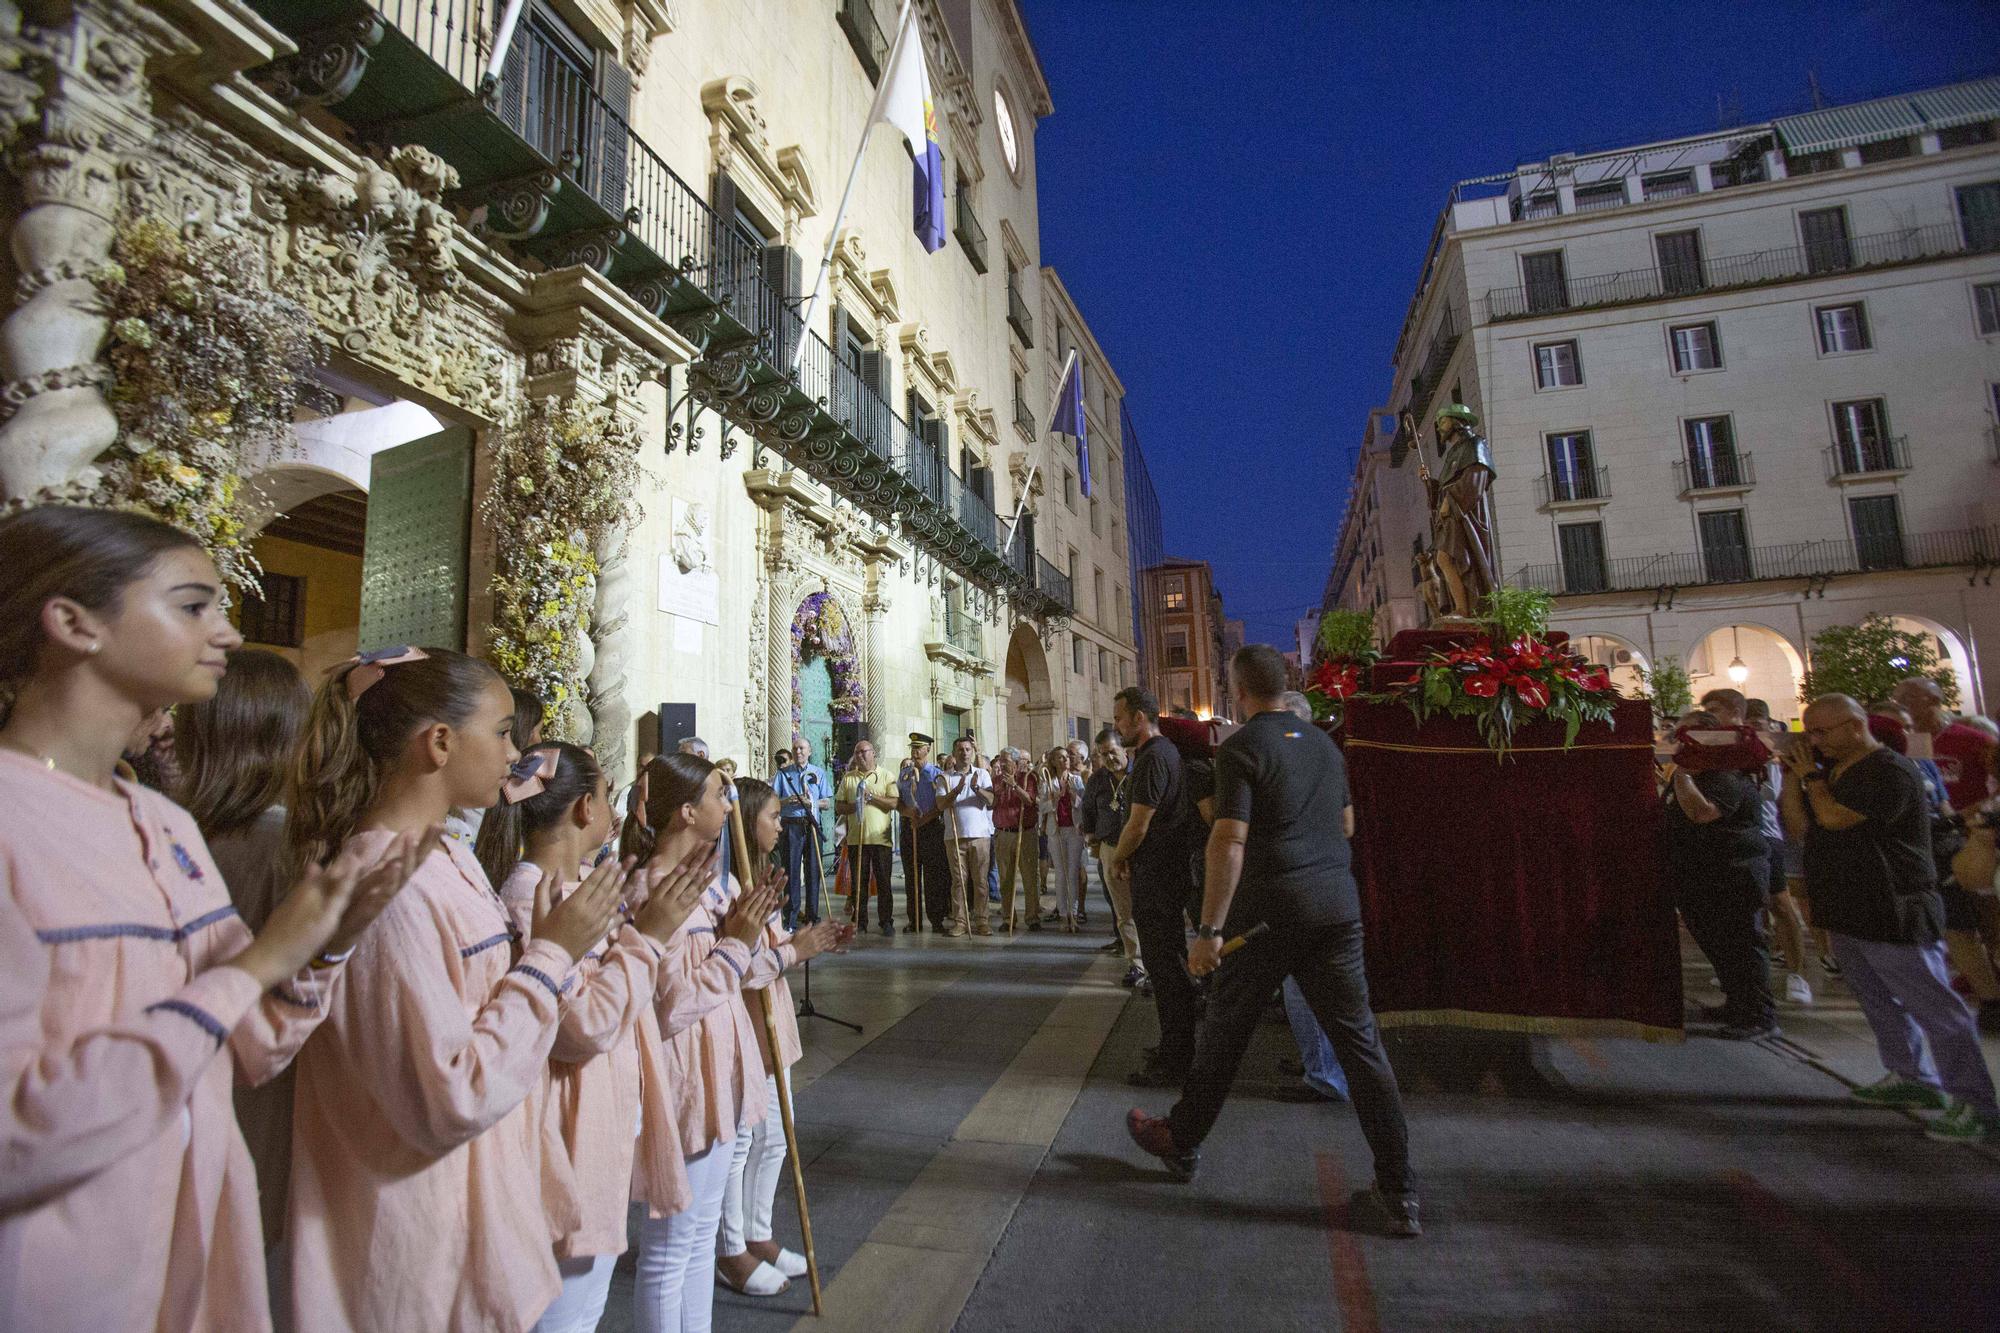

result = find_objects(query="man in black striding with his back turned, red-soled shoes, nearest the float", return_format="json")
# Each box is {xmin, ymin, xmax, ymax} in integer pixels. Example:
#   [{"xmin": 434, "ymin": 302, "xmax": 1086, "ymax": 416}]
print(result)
[{"xmin": 1126, "ymin": 644, "xmax": 1422, "ymax": 1237}]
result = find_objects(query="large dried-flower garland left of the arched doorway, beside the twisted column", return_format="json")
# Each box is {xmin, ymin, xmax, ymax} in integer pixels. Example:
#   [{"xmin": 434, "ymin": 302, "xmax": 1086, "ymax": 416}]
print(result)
[{"xmin": 90, "ymin": 218, "xmax": 320, "ymax": 590}]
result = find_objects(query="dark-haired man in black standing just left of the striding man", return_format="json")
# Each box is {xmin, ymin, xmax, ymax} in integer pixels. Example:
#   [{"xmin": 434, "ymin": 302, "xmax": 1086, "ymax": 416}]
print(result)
[{"xmin": 1104, "ymin": 685, "xmax": 1192, "ymax": 1087}]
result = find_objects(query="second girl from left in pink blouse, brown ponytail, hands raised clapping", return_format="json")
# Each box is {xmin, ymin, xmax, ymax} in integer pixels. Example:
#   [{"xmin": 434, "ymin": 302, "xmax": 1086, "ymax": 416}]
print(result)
[{"xmin": 288, "ymin": 648, "xmax": 630, "ymax": 1333}]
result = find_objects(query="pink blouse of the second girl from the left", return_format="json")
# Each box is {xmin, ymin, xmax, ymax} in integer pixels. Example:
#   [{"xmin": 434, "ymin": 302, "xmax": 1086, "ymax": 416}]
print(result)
[{"xmin": 290, "ymin": 829, "xmax": 576, "ymax": 1333}]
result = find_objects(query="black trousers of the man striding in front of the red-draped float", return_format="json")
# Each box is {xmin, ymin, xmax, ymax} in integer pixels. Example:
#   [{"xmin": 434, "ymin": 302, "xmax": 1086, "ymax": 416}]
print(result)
[{"xmin": 1148, "ymin": 921, "xmax": 1416, "ymax": 1195}]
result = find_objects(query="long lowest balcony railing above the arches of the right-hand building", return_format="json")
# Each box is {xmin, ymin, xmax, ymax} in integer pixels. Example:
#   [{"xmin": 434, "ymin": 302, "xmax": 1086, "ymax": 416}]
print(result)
[{"xmin": 1508, "ymin": 526, "xmax": 2000, "ymax": 596}]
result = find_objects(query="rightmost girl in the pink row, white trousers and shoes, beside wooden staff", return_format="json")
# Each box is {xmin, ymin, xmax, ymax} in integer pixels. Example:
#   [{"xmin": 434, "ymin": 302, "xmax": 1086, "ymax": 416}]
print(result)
[{"xmin": 716, "ymin": 779, "xmax": 854, "ymax": 1297}]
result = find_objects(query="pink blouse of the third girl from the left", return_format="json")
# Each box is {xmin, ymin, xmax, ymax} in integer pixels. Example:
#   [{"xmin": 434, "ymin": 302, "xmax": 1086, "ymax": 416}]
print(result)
[{"xmin": 500, "ymin": 861, "xmax": 694, "ymax": 1259}]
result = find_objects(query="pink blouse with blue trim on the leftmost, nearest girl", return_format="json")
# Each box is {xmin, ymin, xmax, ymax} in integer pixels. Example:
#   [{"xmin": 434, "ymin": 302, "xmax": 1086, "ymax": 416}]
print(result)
[{"xmin": 0, "ymin": 751, "xmax": 346, "ymax": 1333}]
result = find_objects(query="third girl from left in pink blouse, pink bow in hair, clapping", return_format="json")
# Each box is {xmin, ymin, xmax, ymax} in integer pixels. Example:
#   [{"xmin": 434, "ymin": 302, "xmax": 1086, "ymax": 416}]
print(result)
[{"xmin": 478, "ymin": 743, "xmax": 710, "ymax": 1333}]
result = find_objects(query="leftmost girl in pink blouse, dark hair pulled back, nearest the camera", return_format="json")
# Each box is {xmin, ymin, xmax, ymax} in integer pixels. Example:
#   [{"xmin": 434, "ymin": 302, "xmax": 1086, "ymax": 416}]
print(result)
[{"xmin": 0, "ymin": 506, "xmax": 436, "ymax": 1333}]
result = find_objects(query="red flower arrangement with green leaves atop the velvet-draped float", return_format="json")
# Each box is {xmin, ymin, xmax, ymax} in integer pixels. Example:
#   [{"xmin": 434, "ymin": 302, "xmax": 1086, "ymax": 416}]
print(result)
[{"xmin": 1406, "ymin": 634, "xmax": 1616, "ymax": 755}]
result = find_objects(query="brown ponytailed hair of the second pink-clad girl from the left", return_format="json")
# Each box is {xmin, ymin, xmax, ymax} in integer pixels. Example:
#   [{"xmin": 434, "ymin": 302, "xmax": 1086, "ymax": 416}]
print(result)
[{"xmin": 284, "ymin": 648, "xmax": 504, "ymax": 871}]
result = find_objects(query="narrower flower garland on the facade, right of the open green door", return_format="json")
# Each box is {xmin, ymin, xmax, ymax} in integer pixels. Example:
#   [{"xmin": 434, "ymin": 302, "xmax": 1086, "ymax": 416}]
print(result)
[{"xmin": 480, "ymin": 398, "xmax": 640, "ymax": 739}]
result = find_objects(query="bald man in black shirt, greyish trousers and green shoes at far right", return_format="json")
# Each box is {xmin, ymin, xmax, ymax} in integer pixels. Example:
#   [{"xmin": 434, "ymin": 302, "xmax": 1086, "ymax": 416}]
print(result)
[{"xmin": 1778, "ymin": 695, "xmax": 2000, "ymax": 1143}]
